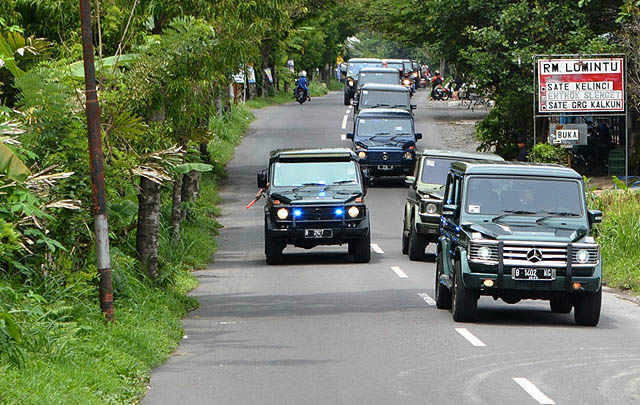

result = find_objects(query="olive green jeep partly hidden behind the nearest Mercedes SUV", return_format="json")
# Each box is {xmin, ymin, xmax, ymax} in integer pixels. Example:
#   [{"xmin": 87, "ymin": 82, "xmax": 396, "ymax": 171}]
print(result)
[{"xmin": 402, "ymin": 149, "xmax": 504, "ymax": 260}]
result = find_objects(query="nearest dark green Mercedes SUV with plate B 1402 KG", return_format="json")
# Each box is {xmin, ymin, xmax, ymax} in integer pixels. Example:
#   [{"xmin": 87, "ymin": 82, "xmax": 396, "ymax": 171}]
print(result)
[{"xmin": 435, "ymin": 162, "xmax": 602, "ymax": 326}]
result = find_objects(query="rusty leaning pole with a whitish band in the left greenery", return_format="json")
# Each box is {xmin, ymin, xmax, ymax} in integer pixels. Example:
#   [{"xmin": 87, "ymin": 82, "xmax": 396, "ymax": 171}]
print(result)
[{"xmin": 80, "ymin": 0, "xmax": 114, "ymax": 322}]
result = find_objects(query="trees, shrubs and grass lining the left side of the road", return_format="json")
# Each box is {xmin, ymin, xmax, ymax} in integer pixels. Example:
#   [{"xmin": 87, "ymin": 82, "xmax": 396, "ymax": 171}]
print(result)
[{"xmin": 0, "ymin": 0, "xmax": 350, "ymax": 404}]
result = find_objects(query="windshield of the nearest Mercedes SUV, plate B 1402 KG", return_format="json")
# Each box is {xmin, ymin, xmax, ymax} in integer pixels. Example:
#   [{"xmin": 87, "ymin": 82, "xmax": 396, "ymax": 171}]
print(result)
[{"xmin": 465, "ymin": 177, "xmax": 583, "ymax": 216}]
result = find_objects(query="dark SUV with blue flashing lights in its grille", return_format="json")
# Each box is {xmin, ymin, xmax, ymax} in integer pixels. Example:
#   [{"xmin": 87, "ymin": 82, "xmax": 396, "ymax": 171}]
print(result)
[{"xmin": 258, "ymin": 148, "xmax": 371, "ymax": 264}]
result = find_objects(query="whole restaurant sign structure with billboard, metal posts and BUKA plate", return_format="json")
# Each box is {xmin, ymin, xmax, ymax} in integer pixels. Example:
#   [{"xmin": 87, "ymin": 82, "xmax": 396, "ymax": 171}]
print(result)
[{"xmin": 533, "ymin": 55, "xmax": 629, "ymax": 182}]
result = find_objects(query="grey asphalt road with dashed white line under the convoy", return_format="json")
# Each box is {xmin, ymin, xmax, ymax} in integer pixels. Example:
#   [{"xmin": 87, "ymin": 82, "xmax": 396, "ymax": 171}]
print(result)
[{"xmin": 143, "ymin": 92, "xmax": 640, "ymax": 404}]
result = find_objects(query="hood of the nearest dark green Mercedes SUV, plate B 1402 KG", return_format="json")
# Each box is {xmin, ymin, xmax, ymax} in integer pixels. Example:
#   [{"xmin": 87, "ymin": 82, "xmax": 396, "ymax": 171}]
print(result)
[{"xmin": 464, "ymin": 222, "xmax": 588, "ymax": 243}]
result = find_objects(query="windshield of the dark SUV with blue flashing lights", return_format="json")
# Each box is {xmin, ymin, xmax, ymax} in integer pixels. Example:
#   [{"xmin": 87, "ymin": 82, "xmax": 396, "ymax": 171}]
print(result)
[{"xmin": 273, "ymin": 161, "xmax": 358, "ymax": 187}]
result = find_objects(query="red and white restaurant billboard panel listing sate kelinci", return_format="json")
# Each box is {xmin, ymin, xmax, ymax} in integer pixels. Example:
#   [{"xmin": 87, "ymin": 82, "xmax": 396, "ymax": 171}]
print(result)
[{"xmin": 537, "ymin": 57, "xmax": 625, "ymax": 114}]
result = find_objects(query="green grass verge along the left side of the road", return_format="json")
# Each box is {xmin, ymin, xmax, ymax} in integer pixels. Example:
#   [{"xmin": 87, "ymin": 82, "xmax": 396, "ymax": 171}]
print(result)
[{"xmin": 0, "ymin": 106, "xmax": 253, "ymax": 404}]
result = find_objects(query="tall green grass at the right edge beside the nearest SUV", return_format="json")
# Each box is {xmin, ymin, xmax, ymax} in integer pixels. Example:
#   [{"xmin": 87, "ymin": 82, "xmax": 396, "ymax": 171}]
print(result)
[{"xmin": 591, "ymin": 190, "xmax": 640, "ymax": 293}]
